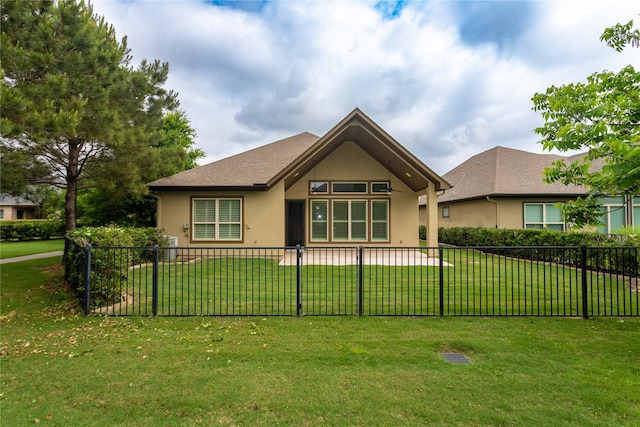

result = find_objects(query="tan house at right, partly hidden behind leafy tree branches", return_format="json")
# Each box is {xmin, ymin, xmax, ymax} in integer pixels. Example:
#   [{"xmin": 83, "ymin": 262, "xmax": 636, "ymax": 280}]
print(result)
[{"xmin": 438, "ymin": 147, "xmax": 640, "ymax": 233}]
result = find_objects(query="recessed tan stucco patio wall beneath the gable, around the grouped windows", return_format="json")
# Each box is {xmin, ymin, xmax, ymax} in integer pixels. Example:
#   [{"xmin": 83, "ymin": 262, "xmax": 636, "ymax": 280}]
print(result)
[{"xmin": 285, "ymin": 142, "xmax": 418, "ymax": 246}]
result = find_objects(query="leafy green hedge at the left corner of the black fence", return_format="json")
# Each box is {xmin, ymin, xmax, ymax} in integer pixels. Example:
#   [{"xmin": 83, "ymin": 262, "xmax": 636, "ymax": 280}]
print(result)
[{"xmin": 64, "ymin": 227, "xmax": 168, "ymax": 305}]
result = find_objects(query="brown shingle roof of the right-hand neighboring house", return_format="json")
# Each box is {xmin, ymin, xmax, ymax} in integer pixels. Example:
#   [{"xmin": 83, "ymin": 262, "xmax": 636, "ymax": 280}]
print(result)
[{"xmin": 438, "ymin": 146, "xmax": 587, "ymax": 203}]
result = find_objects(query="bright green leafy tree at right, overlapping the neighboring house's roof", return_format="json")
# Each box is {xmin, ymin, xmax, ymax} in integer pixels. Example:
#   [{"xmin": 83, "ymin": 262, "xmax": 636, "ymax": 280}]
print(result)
[{"xmin": 532, "ymin": 21, "xmax": 640, "ymax": 227}]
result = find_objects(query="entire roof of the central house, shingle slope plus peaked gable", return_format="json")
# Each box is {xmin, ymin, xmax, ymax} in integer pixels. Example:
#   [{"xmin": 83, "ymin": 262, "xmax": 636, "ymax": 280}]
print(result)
[{"xmin": 148, "ymin": 108, "xmax": 449, "ymax": 191}]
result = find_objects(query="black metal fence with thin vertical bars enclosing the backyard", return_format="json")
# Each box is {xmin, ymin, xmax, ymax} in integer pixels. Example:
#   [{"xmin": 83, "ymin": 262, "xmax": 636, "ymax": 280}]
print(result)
[{"xmin": 65, "ymin": 241, "xmax": 640, "ymax": 318}]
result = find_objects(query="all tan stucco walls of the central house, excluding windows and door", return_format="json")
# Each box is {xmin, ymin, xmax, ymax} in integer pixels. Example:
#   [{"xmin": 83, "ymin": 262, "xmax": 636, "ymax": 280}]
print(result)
[{"xmin": 158, "ymin": 142, "xmax": 437, "ymax": 247}]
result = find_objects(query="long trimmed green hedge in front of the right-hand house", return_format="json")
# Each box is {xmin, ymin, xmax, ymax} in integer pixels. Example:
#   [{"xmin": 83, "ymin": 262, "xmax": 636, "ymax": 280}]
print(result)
[{"xmin": 438, "ymin": 227, "xmax": 640, "ymax": 275}]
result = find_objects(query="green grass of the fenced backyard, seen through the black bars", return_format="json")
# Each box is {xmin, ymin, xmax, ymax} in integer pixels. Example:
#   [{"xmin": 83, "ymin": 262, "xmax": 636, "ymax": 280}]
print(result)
[{"xmin": 91, "ymin": 250, "xmax": 640, "ymax": 317}]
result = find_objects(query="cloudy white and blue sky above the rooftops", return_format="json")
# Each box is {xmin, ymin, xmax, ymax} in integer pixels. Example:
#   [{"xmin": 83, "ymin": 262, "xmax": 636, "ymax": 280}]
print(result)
[{"xmin": 91, "ymin": 0, "xmax": 640, "ymax": 174}]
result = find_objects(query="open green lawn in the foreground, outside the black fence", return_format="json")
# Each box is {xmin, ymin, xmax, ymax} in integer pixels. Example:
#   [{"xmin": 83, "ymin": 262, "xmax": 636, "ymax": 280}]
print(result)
[{"xmin": 0, "ymin": 259, "xmax": 640, "ymax": 426}]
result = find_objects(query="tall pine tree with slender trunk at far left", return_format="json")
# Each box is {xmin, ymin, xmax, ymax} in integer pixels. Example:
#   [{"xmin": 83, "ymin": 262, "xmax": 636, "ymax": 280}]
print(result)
[{"xmin": 0, "ymin": 0, "xmax": 178, "ymax": 230}]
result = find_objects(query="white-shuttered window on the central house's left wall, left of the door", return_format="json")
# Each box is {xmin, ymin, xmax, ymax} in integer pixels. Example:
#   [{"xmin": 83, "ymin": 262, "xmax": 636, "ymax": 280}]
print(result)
[{"xmin": 192, "ymin": 199, "xmax": 242, "ymax": 240}]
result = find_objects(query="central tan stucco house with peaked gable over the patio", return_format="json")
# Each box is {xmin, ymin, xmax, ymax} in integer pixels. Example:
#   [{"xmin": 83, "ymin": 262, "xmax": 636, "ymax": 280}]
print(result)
[{"xmin": 148, "ymin": 109, "xmax": 449, "ymax": 247}]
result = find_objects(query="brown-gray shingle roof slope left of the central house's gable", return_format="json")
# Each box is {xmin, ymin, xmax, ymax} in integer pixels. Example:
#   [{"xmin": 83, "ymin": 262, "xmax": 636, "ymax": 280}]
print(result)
[{"xmin": 147, "ymin": 132, "xmax": 319, "ymax": 190}]
